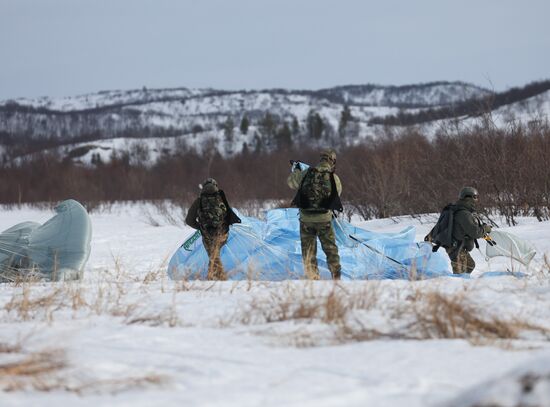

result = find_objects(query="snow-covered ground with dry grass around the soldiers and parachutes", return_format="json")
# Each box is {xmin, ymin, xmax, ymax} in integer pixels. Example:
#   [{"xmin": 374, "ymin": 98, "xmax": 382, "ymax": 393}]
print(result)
[{"xmin": 0, "ymin": 205, "xmax": 550, "ymax": 407}]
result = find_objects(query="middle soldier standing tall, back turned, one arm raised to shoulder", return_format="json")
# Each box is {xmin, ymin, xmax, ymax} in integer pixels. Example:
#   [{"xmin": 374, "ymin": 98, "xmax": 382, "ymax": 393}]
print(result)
[{"xmin": 287, "ymin": 150, "xmax": 342, "ymax": 280}]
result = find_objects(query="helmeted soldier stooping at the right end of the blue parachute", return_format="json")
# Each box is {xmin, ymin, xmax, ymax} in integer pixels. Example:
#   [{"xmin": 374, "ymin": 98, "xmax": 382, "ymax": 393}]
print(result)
[{"xmin": 446, "ymin": 187, "xmax": 491, "ymax": 274}]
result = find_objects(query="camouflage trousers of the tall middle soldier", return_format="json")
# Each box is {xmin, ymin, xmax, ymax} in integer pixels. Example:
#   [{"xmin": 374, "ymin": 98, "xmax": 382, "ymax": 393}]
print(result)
[{"xmin": 300, "ymin": 222, "xmax": 341, "ymax": 280}]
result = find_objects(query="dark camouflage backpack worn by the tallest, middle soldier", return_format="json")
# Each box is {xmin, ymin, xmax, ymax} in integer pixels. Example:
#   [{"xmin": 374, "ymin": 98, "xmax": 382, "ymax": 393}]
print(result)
[{"xmin": 292, "ymin": 168, "xmax": 343, "ymax": 213}]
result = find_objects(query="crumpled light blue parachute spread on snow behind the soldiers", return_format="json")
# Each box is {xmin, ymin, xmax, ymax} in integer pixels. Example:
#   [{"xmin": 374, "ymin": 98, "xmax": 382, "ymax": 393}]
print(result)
[{"xmin": 168, "ymin": 208, "xmax": 452, "ymax": 281}]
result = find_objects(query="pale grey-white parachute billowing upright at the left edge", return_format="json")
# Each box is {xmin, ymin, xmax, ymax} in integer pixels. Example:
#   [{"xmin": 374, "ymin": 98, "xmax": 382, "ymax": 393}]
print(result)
[{"xmin": 0, "ymin": 199, "xmax": 92, "ymax": 281}]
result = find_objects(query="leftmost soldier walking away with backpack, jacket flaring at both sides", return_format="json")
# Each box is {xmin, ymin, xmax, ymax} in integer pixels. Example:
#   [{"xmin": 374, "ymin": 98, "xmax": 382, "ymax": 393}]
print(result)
[{"xmin": 185, "ymin": 178, "xmax": 241, "ymax": 280}]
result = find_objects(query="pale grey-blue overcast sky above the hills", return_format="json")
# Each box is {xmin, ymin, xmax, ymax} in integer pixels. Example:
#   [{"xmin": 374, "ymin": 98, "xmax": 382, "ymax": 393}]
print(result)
[{"xmin": 0, "ymin": 0, "xmax": 550, "ymax": 99}]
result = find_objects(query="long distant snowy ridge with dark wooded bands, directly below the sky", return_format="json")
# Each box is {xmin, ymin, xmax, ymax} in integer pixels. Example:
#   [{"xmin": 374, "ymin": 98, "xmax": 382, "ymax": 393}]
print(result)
[{"xmin": 0, "ymin": 82, "xmax": 488, "ymax": 140}]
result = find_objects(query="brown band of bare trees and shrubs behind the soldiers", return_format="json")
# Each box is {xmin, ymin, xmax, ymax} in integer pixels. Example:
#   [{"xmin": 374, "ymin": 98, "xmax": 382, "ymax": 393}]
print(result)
[{"xmin": 0, "ymin": 118, "xmax": 550, "ymax": 224}]
